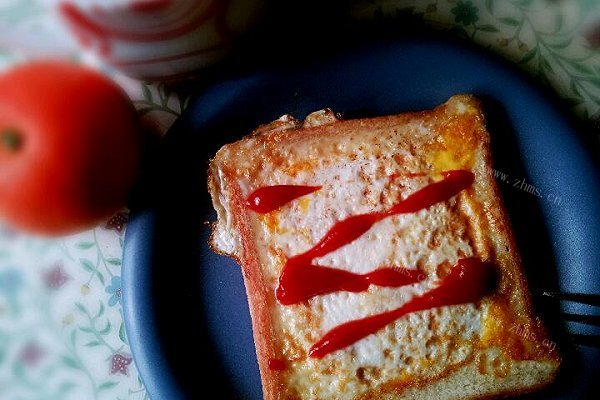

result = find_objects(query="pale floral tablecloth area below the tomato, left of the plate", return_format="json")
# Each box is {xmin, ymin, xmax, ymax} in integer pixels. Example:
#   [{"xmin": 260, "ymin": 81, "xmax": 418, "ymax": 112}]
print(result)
[{"xmin": 0, "ymin": 224, "xmax": 148, "ymax": 400}]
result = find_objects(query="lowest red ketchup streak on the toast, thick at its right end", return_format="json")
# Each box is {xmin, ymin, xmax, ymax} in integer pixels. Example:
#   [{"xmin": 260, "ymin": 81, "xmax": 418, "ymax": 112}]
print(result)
[{"xmin": 308, "ymin": 258, "xmax": 495, "ymax": 358}]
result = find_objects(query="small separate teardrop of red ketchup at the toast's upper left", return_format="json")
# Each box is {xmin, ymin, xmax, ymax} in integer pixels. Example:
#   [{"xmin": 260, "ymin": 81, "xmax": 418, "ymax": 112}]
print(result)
[{"xmin": 246, "ymin": 185, "xmax": 321, "ymax": 214}]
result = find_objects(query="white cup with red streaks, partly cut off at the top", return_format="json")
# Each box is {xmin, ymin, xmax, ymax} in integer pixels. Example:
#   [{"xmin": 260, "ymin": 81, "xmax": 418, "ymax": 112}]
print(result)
[{"xmin": 58, "ymin": 0, "xmax": 265, "ymax": 80}]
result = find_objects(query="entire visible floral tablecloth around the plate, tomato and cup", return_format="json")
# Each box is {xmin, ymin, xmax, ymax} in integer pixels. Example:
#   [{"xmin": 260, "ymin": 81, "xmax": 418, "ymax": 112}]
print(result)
[{"xmin": 0, "ymin": 0, "xmax": 600, "ymax": 400}]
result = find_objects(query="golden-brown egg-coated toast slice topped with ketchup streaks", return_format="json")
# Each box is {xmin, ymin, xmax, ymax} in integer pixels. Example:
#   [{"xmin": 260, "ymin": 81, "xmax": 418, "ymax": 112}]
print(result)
[{"xmin": 209, "ymin": 95, "xmax": 560, "ymax": 399}]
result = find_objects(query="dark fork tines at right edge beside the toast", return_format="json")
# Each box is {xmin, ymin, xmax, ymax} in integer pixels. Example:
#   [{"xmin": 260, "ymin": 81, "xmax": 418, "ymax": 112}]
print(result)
[{"xmin": 538, "ymin": 291, "xmax": 600, "ymax": 348}]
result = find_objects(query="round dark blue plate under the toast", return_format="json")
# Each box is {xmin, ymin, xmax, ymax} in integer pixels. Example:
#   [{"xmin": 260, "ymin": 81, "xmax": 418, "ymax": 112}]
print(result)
[{"xmin": 123, "ymin": 39, "xmax": 600, "ymax": 400}]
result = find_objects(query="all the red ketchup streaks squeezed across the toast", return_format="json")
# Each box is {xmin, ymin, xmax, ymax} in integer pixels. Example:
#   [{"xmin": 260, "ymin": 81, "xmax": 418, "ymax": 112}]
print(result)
[{"xmin": 246, "ymin": 170, "xmax": 493, "ymax": 358}]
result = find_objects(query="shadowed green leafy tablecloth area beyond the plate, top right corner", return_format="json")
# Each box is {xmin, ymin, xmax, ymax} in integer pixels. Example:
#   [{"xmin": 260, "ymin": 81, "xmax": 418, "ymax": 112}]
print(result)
[{"xmin": 353, "ymin": 0, "xmax": 600, "ymax": 120}]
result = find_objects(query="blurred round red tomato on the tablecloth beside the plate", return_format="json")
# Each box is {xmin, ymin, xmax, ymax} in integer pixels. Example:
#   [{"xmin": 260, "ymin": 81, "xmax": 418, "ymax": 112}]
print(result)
[{"xmin": 0, "ymin": 61, "xmax": 141, "ymax": 234}]
